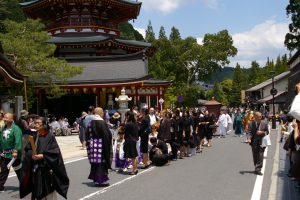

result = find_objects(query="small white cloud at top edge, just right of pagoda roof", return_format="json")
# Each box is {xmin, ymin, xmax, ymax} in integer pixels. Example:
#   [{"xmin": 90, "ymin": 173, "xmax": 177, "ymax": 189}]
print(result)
[{"xmin": 142, "ymin": 0, "xmax": 194, "ymax": 14}]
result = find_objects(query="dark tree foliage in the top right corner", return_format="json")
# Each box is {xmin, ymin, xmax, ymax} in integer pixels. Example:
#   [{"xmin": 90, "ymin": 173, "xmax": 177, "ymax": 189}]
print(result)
[{"xmin": 284, "ymin": 0, "xmax": 300, "ymax": 51}]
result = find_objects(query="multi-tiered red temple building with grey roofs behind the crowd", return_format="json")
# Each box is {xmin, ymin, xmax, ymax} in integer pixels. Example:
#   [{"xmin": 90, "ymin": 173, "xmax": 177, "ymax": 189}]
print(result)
[{"xmin": 21, "ymin": 0, "xmax": 171, "ymax": 114}]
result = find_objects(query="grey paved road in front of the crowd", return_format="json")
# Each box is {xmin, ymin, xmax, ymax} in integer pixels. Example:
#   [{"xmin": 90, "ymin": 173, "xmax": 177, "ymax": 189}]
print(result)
[{"xmin": 0, "ymin": 129, "xmax": 298, "ymax": 200}]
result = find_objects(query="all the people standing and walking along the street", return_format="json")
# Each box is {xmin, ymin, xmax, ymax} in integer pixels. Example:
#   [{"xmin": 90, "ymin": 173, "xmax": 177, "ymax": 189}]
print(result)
[{"xmin": 0, "ymin": 81, "xmax": 300, "ymax": 199}]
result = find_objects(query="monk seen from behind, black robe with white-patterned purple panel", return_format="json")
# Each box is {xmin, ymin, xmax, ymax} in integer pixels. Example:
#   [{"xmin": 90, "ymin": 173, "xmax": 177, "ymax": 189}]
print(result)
[{"xmin": 86, "ymin": 107, "xmax": 112, "ymax": 186}]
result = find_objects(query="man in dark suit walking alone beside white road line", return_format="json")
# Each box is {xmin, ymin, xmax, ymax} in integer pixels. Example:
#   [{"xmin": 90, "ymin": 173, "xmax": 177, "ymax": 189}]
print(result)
[{"xmin": 248, "ymin": 112, "xmax": 269, "ymax": 175}]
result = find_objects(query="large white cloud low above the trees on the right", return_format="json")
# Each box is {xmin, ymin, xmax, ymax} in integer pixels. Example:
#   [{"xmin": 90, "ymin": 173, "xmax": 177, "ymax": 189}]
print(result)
[{"xmin": 231, "ymin": 20, "xmax": 288, "ymax": 68}]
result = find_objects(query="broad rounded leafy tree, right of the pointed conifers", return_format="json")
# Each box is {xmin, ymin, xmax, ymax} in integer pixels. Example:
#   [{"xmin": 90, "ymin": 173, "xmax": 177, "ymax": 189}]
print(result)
[{"xmin": 178, "ymin": 30, "xmax": 237, "ymax": 84}]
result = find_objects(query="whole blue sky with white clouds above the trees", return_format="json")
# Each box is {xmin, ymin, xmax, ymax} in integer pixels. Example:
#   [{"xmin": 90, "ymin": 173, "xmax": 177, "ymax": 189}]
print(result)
[{"xmin": 130, "ymin": 0, "xmax": 291, "ymax": 68}]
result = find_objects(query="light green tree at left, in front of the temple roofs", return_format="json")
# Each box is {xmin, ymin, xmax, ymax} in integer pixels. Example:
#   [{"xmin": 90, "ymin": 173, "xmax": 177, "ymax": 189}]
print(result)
[{"xmin": 0, "ymin": 19, "xmax": 82, "ymax": 98}]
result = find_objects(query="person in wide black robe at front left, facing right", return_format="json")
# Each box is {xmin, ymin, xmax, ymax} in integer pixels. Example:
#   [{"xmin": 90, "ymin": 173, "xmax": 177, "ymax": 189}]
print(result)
[{"xmin": 20, "ymin": 117, "xmax": 69, "ymax": 200}]
